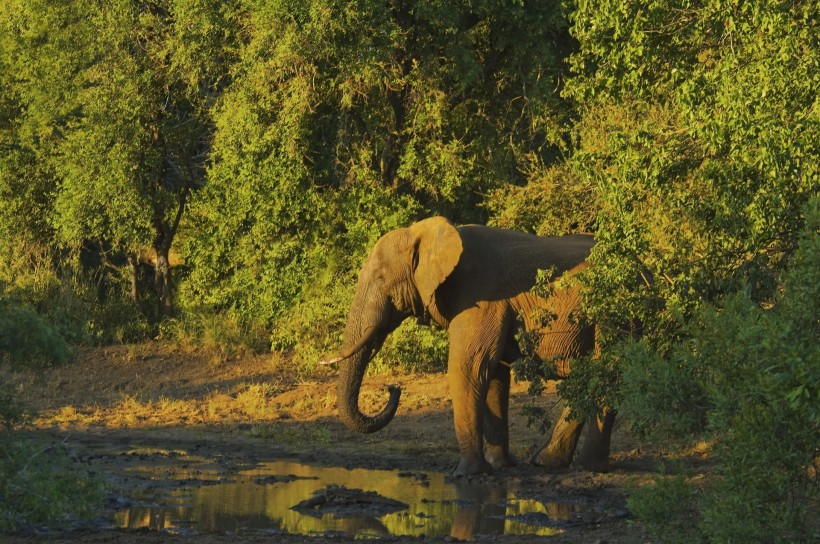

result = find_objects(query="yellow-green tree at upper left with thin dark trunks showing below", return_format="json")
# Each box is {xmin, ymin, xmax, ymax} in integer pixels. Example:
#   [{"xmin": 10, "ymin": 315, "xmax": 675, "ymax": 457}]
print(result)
[{"xmin": 4, "ymin": 0, "xmax": 237, "ymax": 315}]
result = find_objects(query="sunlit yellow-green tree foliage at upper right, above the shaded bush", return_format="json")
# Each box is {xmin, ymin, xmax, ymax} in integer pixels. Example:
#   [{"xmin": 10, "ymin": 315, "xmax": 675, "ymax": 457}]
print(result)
[{"xmin": 566, "ymin": 1, "xmax": 820, "ymax": 344}]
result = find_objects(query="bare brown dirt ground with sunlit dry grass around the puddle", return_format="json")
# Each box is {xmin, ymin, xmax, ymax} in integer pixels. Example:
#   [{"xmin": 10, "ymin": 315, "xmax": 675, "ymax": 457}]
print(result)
[{"xmin": 0, "ymin": 343, "xmax": 684, "ymax": 544}]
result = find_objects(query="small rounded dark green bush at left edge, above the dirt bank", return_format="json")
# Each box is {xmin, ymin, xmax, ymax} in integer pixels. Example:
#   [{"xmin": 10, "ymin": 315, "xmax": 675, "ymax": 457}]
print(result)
[{"xmin": 0, "ymin": 300, "xmax": 73, "ymax": 367}]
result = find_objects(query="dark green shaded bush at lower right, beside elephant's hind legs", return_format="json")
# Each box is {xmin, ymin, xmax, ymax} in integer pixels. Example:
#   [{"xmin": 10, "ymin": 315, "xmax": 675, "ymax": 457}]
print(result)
[{"xmin": 619, "ymin": 197, "xmax": 820, "ymax": 543}]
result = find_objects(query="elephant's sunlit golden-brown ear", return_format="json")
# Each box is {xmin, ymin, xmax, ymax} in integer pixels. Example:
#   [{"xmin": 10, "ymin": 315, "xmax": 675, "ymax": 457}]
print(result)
[{"xmin": 410, "ymin": 217, "xmax": 463, "ymax": 308}]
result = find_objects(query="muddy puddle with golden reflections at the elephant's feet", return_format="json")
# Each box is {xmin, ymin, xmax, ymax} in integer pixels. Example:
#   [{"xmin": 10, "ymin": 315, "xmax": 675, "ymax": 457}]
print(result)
[{"xmin": 116, "ymin": 461, "xmax": 578, "ymax": 539}]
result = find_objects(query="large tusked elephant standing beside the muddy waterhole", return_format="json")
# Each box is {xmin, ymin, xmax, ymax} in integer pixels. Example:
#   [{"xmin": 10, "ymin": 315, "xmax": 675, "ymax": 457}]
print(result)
[{"xmin": 322, "ymin": 217, "xmax": 614, "ymax": 475}]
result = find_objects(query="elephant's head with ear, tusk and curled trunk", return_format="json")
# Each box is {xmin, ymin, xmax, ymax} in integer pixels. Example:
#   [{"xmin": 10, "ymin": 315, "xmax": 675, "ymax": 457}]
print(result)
[{"xmin": 325, "ymin": 217, "xmax": 462, "ymax": 433}]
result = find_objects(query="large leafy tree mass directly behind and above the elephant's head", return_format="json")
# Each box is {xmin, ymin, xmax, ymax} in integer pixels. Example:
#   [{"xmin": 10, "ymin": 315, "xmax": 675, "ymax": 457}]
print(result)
[{"xmin": 185, "ymin": 0, "xmax": 572, "ymax": 352}]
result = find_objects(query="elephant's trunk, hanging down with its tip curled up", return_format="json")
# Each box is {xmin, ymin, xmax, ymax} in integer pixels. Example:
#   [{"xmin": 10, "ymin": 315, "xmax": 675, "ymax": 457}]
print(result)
[{"xmin": 336, "ymin": 288, "xmax": 401, "ymax": 433}]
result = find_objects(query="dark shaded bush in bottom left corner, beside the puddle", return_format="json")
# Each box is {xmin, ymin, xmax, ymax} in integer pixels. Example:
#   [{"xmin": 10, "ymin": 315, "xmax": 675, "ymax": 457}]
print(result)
[{"xmin": 0, "ymin": 431, "xmax": 105, "ymax": 531}]
